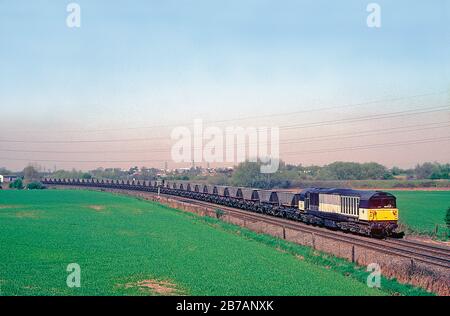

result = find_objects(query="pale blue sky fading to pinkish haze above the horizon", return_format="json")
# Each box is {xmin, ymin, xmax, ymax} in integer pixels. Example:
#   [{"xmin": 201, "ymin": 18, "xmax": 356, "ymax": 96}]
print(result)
[{"xmin": 0, "ymin": 0, "xmax": 450, "ymax": 170}]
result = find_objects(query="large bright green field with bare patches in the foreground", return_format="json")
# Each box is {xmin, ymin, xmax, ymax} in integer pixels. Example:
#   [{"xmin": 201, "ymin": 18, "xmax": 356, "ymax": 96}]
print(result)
[{"xmin": 0, "ymin": 190, "xmax": 425, "ymax": 295}]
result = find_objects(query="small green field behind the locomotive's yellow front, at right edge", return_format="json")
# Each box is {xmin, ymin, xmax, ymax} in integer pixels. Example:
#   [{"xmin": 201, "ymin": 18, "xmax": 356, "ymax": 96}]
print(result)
[{"xmin": 389, "ymin": 191, "xmax": 450, "ymax": 238}]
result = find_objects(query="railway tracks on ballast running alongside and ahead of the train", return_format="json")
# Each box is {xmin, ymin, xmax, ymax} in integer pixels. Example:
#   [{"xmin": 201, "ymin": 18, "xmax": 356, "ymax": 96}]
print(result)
[{"xmin": 173, "ymin": 194, "xmax": 450, "ymax": 269}]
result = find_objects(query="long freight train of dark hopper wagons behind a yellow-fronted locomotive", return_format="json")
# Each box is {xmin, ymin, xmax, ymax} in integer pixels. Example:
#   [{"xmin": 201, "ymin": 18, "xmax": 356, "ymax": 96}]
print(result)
[{"xmin": 42, "ymin": 179, "xmax": 403, "ymax": 238}]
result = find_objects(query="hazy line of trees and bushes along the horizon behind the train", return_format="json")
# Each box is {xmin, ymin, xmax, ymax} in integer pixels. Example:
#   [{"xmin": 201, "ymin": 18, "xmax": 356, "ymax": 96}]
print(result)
[{"xmin": 0, "ymin": 161, "xmax": 450, "ymax": 188}]
